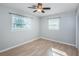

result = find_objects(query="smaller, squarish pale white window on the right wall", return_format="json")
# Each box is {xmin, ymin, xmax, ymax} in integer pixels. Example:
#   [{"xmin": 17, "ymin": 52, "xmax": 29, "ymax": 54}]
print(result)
[{"xmin": 48, "ymin": 18, "xmax": 59, "ymax": 30}]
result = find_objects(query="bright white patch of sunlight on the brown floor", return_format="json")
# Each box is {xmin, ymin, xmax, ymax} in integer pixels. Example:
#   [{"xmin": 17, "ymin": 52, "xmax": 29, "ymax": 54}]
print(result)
[{"xmin": 48, "ymin": 48, "xmax": 67, "ymax": 56}]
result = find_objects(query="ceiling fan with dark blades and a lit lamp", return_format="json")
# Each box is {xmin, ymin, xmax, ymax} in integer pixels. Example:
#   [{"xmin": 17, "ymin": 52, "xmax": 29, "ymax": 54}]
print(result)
[{"xmin": 28, "ymin": 3, "xmax": 51, "ymax": 13}]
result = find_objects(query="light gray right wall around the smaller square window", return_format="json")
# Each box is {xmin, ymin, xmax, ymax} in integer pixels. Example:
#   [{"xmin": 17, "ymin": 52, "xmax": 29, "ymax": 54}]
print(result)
[{"xmin": 40, "ymin": 11, "xmax": 76, "ymax": 45}]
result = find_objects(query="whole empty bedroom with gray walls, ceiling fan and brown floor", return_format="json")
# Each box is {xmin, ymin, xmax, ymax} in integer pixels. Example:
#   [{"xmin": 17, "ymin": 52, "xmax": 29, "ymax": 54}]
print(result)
[{"xmin": 0, "ymin": 3, "xmax": 79, "ymax": 56}]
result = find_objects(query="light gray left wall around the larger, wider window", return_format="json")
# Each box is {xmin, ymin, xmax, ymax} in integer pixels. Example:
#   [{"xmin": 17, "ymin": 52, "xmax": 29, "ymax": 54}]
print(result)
[{"xmin": 0, "ymin": 6, "xmax": 39, "ymax": 50}]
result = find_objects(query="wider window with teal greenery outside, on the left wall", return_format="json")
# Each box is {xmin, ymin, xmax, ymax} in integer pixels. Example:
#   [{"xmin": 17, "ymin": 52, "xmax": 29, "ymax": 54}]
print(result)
[{"xmin": 12, "ymin": 14, "xmax": 31, "ymax": 31}]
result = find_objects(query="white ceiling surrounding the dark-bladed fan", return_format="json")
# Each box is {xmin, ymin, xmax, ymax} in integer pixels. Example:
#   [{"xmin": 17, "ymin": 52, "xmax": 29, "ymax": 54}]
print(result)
[{"xmin": 0, "ymin": 3, "xmax": 78, "ymax": 16}]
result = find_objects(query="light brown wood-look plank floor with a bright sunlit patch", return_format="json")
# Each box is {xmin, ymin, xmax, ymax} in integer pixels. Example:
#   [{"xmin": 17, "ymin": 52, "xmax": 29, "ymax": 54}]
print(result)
[{"xmin": 0, "ymin": 39, "xmax": 78, "ymax": 56}]
